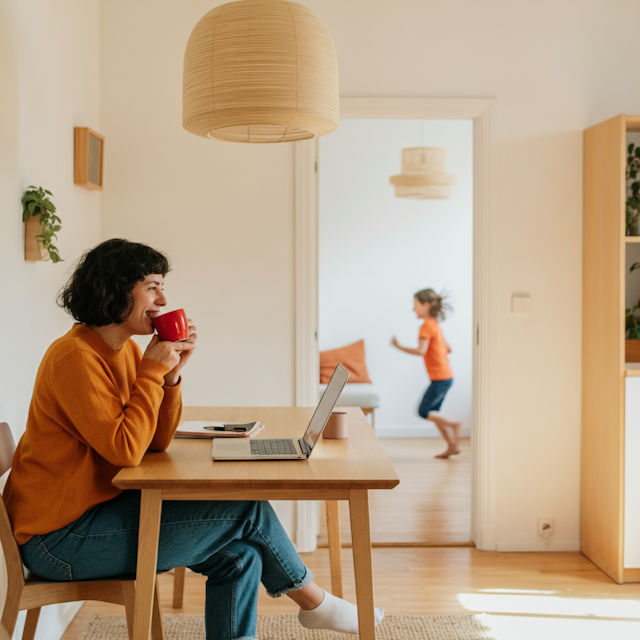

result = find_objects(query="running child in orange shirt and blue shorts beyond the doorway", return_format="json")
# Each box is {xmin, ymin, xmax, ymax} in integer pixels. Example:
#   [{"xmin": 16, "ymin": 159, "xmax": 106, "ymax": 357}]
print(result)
[{"xmin": 391, "ymin": 289, "xmax": 462, "ymax": 459}]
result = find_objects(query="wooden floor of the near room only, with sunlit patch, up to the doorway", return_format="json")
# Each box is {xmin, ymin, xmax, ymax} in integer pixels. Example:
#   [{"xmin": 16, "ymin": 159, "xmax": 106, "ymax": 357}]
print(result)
[{"xmin": 64, "ymin": 548, "xmax": 640, "ymax": 640}]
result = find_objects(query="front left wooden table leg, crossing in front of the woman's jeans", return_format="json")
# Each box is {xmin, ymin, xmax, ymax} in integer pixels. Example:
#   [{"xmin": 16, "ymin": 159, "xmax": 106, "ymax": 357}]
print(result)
[{"xmin": 133, "ymin": 489, "xmax": 162, "ymax": 640}]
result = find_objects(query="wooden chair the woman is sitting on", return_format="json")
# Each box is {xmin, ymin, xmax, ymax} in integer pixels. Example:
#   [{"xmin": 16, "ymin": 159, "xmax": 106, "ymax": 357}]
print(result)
[{"xmin": 0, "ymin": 422, "xmax": 164, "ymax": 640}]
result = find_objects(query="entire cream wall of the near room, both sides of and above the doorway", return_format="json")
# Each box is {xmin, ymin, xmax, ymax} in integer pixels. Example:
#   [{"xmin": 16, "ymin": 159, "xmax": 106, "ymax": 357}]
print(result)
[{"xmin": 96, "ymin": 0, "xmax": 640, "ymax": 550}]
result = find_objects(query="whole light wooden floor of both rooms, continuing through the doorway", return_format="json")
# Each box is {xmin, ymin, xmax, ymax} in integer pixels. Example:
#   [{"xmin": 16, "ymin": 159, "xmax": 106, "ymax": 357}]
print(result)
[{"xmin": 64, "ymin": 439, "xmax": 640, "ymax": 640}]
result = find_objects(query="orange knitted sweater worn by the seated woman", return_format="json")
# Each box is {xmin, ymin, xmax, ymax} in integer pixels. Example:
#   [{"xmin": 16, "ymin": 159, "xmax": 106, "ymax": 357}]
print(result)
[{"xmin": 4, "ymin": 324, "xmax": 182, "ymax": 544}]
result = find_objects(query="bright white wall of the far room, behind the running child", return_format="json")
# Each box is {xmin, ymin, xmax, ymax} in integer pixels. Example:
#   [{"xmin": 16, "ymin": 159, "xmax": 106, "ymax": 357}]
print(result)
[{"xmin": 318, "ymin": 119, "xmax": 473, "ymax": 437}]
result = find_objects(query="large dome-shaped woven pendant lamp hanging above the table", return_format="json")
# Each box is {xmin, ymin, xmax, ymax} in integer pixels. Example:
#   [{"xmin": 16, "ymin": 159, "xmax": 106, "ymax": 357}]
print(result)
[{"xmin": 182, "ymin": 0, "xmax": 338, "ymax": 142}]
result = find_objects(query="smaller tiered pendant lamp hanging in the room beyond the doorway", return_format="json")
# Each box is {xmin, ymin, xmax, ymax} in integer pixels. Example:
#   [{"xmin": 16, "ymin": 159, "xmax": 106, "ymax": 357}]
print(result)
[{"xmin": 389, "ymin": 147, "xmax": 458, "ymax": 199}]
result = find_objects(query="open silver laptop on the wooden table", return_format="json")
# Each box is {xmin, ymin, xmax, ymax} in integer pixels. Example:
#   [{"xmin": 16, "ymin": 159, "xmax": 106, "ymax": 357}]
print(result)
[{"xmin": 211, "ymin": 364, "xmax": 349, "ymax": 460}]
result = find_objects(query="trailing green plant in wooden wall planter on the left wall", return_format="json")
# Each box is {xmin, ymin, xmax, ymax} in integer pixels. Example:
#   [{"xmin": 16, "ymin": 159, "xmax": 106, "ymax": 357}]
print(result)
[{"xmin": 22, "ymin": 186, "xmax": 63, "ymax": 262}]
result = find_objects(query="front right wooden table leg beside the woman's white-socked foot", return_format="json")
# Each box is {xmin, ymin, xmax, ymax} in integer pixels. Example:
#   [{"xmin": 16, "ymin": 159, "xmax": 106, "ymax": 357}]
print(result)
[{"xmin": 349, "ymin": 489, "xmax": 376, "ymax": 640}]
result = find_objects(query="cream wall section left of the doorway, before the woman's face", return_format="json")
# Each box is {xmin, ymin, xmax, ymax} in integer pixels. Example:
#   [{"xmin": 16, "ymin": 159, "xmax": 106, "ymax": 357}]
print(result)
[{"xmin": 101, "ymin": 0, "xmax": 294, "ymax": 406}]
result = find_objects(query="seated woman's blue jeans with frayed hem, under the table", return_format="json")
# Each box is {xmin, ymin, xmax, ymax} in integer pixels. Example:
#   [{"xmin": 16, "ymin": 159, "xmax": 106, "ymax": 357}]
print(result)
[{"xmin": 20, "ymin": 491, "xmax": 313, "ymax": 640}]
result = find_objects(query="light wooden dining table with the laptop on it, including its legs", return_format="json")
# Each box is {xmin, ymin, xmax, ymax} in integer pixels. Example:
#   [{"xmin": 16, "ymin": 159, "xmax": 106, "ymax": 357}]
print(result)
[{"xmin": 113, "ymin": 407, "xmax": 400, "ymax": 640}]
